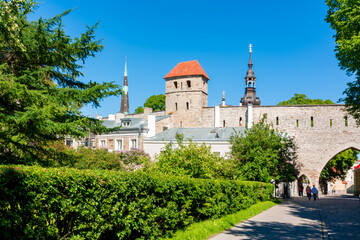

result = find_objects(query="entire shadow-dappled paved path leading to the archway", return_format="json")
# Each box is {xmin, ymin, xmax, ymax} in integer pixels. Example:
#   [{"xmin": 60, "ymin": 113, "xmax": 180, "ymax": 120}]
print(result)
[{"xmin": 211, "ymin": 196, "xmax": 360, "ymax": 240}]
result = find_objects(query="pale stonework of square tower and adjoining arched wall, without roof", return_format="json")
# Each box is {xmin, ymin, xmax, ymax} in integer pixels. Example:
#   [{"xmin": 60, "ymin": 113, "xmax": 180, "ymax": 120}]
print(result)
[{"xmin": 165, "ymin": 61, "xmax": 360, "ymax": 192}]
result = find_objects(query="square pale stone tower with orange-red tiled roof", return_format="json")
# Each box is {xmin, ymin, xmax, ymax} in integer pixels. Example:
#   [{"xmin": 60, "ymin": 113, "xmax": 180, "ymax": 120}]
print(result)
[{"xmin": 164, "ymin": 60, "xmax": 209, "ymax": 127}]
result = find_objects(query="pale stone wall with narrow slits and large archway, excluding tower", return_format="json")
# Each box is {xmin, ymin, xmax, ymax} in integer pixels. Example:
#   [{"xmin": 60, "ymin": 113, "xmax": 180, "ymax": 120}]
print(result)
[{"xmin": 181, "ymin": 105, "xmax": 360, "ymax": 186}]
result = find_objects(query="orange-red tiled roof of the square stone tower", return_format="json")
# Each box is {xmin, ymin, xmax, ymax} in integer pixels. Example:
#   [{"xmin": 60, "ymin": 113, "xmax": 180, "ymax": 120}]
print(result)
[{"xmin": 164, "ymin": 60, "xmax": 209, "ymax": 80}]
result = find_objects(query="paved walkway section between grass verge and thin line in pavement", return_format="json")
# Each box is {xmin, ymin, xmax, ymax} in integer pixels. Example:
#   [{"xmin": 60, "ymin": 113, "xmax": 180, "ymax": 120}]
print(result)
[{"xmin": 211, "ymin": 198, "xmax": 325, "ymax": 240}]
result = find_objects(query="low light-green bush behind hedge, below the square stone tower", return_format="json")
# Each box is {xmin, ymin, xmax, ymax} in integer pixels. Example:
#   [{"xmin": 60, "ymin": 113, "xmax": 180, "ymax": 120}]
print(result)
[{"xmin": 146, "ymin": 137, "xmax": 231, "ymax": 179}]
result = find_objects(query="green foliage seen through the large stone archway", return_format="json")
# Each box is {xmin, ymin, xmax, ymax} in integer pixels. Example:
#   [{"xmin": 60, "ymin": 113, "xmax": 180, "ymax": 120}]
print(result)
[{"xmin": 320, "ymin": 149, "xmax": 359, "ymax": 183}]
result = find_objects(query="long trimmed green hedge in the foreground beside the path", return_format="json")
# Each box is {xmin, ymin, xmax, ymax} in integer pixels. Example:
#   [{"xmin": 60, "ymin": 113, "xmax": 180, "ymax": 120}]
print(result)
[{"xmin": 0, "ymin": 166, "xmax": 273, "ymax": 239}]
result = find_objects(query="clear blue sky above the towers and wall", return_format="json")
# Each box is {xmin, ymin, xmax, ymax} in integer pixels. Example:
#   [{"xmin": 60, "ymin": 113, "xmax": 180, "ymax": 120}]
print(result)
[{"xmin": 31, "ymin": 0, "xmax": 353, "ymax": 116}]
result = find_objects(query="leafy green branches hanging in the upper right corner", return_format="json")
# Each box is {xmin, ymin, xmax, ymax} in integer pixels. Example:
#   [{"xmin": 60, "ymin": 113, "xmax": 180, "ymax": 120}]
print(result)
[{"xmin": 325, "ymin": 0, "xmax": 360, "ymax": 125}]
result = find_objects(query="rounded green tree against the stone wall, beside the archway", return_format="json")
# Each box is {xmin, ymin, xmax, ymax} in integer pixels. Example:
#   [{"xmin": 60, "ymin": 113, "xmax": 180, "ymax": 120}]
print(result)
[{"xmin": 230, "ymin": 118, "xmax": 296, "ymax": 182}]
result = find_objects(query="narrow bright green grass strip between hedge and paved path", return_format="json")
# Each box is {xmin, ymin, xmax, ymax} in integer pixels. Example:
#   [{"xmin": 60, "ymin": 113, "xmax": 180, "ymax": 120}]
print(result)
[{"xmin": 162, "ymin": 200, "xmax": 280, "ymax": 240}]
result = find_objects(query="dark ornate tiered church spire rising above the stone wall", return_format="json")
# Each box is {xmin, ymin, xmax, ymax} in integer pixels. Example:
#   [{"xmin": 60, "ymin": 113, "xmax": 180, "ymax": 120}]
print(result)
[{"xmin": 240, "ymin": 44, "xmax": 261, "ymax": 106}]
